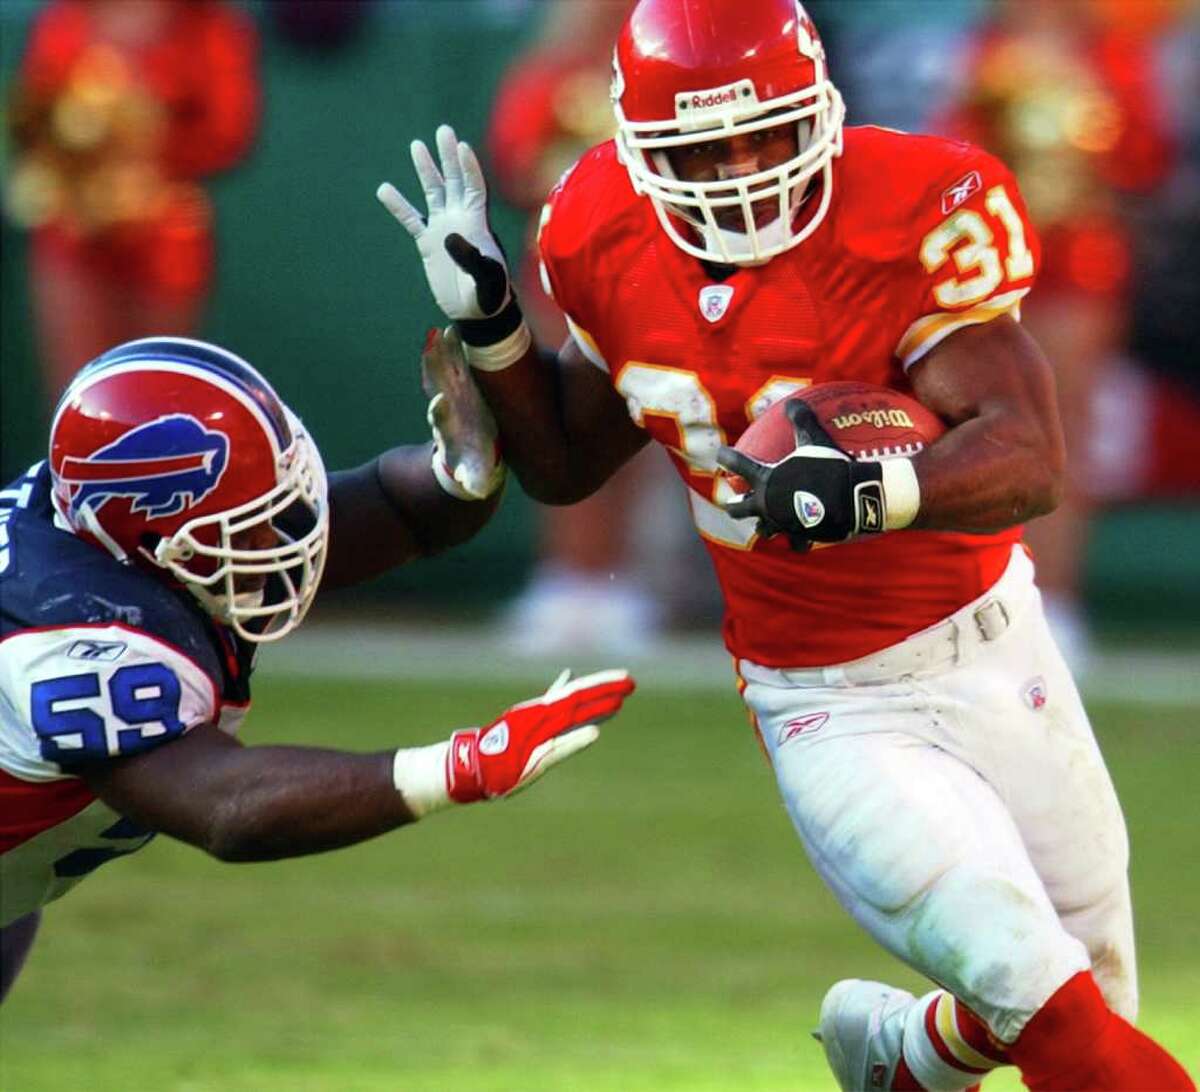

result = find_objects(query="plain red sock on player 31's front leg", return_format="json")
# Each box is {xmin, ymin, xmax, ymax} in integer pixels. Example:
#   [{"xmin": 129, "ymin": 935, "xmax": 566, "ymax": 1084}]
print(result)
[{"xmin": 1008, "ymin": 971, "xmax": 1195, "ymax": 1092}]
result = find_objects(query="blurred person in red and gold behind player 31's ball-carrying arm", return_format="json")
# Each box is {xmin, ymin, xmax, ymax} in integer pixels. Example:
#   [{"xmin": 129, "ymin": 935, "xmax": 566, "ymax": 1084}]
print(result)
[{"xmin": 941, "ymin": 0, "xmax": 1182, "ymax": 667}]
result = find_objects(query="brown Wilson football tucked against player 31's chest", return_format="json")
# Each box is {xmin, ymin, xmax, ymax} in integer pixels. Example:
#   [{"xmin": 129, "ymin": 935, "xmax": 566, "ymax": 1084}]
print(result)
[{"xmin": 732, "ymin": 383, "xmax": 946, "ymax": 477}]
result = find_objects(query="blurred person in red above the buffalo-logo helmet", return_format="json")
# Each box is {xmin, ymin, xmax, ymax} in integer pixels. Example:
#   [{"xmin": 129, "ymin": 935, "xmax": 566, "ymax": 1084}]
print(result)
[{"xmin": 6, "ymin": 0, "xmax": 258, "ymax": 402}]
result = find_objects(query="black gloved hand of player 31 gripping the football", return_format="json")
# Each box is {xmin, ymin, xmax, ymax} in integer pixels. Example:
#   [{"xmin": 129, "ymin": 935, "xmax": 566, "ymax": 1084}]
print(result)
[{"xmin": 716, "ymin": 398, "xmax": 886, "ymax": 550}]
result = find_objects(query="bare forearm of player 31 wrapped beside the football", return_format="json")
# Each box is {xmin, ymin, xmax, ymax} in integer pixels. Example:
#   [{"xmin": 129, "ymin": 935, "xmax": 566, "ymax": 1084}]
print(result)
[{"xmin": 911, "ymin": 415, "xmax": 1063, "ymax": 534}]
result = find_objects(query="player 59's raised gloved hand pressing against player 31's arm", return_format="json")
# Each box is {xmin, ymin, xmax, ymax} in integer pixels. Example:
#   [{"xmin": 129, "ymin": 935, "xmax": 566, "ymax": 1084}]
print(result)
[{"xmin": 421, "ymin": 326, "xmax": 504, "ymax": 500}]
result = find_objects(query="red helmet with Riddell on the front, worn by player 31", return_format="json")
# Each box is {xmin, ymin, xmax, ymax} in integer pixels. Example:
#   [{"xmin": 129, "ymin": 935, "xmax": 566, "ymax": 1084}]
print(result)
[{"xmin": 612, "ymin": 0, "xmax": 845, "ymax": 265}]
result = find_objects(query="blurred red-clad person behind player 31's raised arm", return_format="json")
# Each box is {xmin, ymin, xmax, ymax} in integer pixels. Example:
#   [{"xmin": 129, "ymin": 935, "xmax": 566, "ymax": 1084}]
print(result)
[{"xmin": 488, "ymin": 0, "xmax": 683, "ymax": 653}]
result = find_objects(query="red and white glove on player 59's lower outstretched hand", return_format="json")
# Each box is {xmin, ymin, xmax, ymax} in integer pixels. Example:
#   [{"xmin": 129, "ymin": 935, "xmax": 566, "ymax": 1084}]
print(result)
[{"xmin": 446, "ymin": 671, "xmax": 634, "ymax": 804}]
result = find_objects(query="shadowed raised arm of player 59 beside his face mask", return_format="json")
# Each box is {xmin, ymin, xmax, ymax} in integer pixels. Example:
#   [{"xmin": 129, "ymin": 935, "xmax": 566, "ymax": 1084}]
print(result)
[{"xmin": 323, "ymin": 444, "xmax": 500, "ymax": 588}]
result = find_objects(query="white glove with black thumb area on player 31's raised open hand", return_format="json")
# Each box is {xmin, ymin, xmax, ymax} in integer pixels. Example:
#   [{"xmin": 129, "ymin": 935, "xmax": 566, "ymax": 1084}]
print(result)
[{"xmin": 376, "ymin": 125, "xmax": 512, "ymax": 322}]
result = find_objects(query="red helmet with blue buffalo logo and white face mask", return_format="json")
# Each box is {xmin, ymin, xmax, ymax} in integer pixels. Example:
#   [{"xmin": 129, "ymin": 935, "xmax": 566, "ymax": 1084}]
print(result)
[{"xmin": 50, "ymin": 337, "xmax": 329, "ymax": 641}]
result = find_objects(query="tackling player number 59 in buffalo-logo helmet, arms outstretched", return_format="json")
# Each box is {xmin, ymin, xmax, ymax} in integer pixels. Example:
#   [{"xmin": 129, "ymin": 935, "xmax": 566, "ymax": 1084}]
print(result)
[{"xmin": 0, "ymin": 334, "xmax": 634, "ymax": 997}]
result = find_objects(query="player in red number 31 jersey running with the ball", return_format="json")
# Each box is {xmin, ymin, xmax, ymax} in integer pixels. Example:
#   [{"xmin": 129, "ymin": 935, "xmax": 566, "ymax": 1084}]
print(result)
[{"xmin": 379, "ymin": 0, "xmax": 1193, "ymax": 1090}]
